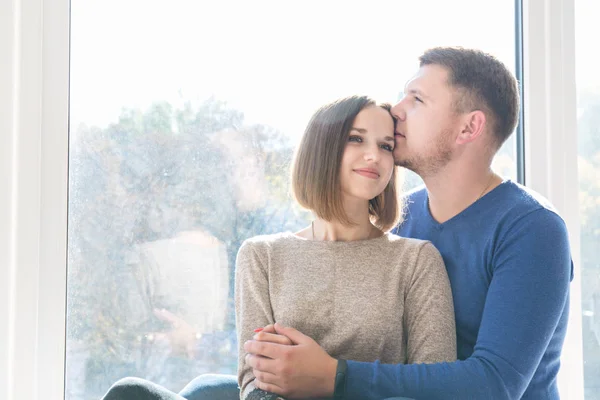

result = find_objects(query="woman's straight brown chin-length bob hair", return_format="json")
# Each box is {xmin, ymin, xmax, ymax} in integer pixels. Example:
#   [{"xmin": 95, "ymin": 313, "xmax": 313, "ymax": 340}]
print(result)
[{"xmin": 291, "ymin": 96, "xmax": 400, "ymax": 231}]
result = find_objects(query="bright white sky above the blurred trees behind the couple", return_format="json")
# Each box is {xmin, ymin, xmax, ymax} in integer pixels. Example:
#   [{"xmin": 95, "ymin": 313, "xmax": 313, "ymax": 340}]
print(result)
[{"xmin": 71, "ymin": 0, "xmax": 600, "ymax": 137}]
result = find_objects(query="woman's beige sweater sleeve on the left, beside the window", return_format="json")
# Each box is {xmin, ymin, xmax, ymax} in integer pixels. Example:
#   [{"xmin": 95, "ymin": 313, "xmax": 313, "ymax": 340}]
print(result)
[{"xmin": 235, "ymin": 241, "xmax": 275, "ymax": 399}]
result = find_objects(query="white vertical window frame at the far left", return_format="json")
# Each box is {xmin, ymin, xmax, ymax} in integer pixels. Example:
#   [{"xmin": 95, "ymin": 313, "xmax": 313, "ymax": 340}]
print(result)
[{"xmin": 0, "ymin": 0, "xmax": 69, "ymax": 400}]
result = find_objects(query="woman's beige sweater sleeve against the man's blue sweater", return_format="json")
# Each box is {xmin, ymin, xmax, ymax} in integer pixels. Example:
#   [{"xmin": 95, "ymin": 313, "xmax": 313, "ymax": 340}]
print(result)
[{"xmin": 404, "ymin": 242, "xmax": 456, "ymax": 364}]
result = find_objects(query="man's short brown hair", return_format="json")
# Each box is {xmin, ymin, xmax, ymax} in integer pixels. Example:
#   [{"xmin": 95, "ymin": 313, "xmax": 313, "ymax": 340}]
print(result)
[{"xmin": 419, "ymin": 47, "xmax": 519, "ymax": 150}]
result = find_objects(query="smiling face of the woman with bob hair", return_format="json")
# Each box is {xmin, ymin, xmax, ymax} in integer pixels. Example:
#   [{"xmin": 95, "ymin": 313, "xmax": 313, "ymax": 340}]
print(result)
[{"xmin": 340, "ymin": 106, "xmax": 395, "ymax": 201}]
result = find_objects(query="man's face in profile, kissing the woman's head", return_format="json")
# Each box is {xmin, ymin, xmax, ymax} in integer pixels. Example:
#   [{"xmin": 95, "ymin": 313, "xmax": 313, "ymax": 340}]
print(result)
[{"xmin": 392, "ymin": 65, "xmax": 460, "ymax": 177}]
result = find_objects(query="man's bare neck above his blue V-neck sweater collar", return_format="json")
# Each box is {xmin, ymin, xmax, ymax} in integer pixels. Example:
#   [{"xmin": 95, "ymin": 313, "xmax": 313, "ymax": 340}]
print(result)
[{"xmin": 423, "ymin": 164, "xmax": 502, "ymax": 223}]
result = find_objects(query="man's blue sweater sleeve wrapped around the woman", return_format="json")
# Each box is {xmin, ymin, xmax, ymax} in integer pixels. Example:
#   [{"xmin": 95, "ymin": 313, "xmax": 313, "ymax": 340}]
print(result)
[{"xmin": 346, "ymin": 209, "xmax": 572, "ymax": 400}]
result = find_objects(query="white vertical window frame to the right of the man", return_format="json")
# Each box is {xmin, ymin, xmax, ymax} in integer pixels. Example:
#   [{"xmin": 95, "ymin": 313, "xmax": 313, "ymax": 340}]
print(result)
[{"xmin": 523, "ymin": 0, "xmax": 584, "ymax": 400}]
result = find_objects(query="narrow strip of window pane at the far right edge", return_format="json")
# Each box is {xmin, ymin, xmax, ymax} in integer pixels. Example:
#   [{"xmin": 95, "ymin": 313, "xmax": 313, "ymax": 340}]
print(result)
[{"xmin": 575, "ymin": 0, "xmax": 600, "ymax": 400}]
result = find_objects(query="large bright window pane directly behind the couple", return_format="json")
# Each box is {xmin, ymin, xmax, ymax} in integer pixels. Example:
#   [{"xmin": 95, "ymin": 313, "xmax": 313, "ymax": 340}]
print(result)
[{"xmin": 66, "ymin": 0, "xmax": 516, "ymax": 399}]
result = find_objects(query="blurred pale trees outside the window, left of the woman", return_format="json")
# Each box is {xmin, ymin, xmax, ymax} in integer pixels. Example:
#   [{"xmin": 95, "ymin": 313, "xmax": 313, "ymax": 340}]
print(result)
[{"xmin": 67, "ymin": 98, "xmax": 309, "ymax": 399}]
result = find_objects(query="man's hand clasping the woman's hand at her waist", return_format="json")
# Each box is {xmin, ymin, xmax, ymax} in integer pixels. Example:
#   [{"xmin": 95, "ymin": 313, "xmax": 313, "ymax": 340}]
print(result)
[{"xmin": 244, "ymin": 323, "xmax": 337, "ymax": 398}]
